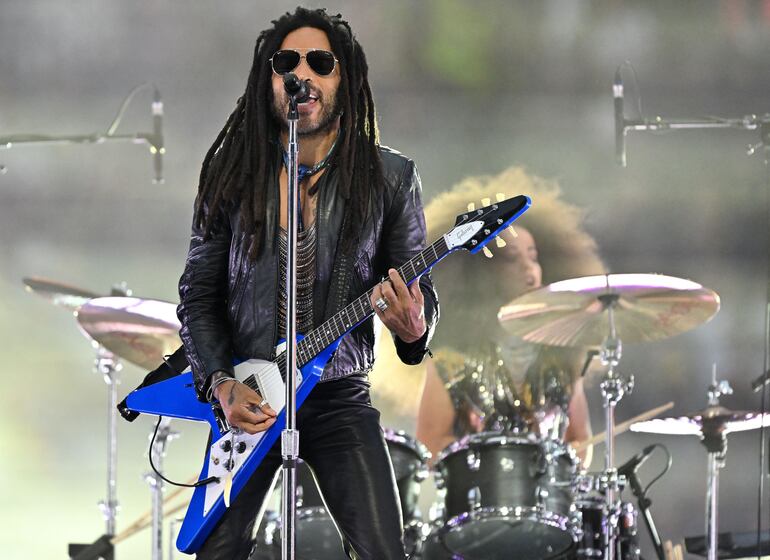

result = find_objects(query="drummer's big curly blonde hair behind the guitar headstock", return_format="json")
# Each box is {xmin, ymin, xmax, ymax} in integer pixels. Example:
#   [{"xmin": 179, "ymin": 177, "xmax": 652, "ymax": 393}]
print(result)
[{"xmin": 371, "ymin": 167, "xmax": 605, "ymax": 415}]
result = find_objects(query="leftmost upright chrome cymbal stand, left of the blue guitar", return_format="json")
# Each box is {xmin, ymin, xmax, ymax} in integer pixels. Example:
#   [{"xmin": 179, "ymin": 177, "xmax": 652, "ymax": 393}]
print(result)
[{"xmin": 93, "ymin": 342, "xmax": 123, "ymax": 537}]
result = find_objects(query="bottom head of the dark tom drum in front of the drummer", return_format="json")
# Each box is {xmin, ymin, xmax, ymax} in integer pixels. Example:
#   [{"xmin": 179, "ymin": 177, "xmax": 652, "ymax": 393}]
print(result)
[{"xmin": 440, "ymin": 515, "xmax": 574, "ymax": 560}]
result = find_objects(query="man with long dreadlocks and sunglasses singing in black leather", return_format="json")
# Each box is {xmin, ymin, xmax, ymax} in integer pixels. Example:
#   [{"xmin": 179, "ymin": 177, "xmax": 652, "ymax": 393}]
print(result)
[{"xmin": 178, "ymin": 8, "xmax": 438, "ymax": 560}]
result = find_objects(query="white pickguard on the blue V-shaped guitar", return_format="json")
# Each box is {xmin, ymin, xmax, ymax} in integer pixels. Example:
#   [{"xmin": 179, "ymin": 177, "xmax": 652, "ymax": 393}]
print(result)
[{"xmin": 203, "ymin": 359, "xmax": 302, "ymax": 515}]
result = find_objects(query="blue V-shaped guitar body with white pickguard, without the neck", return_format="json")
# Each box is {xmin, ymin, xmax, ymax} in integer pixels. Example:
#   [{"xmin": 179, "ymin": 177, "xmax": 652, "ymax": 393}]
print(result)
[{"xmin": 126, "ymin": 341, "xmax": 339, "ymax": 554}]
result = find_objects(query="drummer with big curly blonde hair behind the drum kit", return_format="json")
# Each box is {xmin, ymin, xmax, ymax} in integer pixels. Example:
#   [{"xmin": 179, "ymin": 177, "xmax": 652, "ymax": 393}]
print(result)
[{"xmin": 417, "ymin": 167, "xmax": 604, "ymax": 466}]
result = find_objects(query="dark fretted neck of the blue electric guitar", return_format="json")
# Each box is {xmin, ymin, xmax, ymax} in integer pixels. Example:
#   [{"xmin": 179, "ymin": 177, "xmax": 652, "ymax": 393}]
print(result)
[{"xmin": 276, "ymin": 236, "xmax": 450, "ymax": 371}]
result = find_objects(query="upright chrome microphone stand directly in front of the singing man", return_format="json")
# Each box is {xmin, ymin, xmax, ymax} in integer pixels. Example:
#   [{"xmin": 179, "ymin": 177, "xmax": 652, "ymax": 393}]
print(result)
[{"xmin": 281, "ymin": 86, "xmax": 299, "ymax": 560}]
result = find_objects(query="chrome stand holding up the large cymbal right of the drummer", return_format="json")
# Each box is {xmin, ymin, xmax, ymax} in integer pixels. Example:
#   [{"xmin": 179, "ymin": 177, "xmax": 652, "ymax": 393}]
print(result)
[{"xmin": 598, "ymin": 294, "xmax": 634, "ymax": 560}]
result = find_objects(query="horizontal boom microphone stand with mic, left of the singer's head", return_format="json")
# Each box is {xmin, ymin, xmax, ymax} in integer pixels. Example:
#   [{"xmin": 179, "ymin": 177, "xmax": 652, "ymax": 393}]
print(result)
[{"xmin": 0, "ymin": 84, "xmax": 166, "ymax": 183}]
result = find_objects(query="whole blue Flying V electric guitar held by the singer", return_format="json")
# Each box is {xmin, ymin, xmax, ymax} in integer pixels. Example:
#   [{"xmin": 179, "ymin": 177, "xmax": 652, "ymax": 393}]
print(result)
[{"xmin": 126, "ymin": 196, "xmax": 530, "ymax": 554}]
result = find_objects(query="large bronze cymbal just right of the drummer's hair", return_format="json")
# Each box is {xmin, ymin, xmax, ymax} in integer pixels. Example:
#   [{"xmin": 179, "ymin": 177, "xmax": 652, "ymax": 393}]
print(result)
[{"xmin": 497, "ymin": 274, "xmax": 719, "ymax": 346}]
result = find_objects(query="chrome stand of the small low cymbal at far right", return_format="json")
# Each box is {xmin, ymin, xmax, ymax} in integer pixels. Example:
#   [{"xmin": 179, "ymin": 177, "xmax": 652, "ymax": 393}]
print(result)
[{"xmin": 701, "ymin": 372, "xmax": 733, "ymax": 560}]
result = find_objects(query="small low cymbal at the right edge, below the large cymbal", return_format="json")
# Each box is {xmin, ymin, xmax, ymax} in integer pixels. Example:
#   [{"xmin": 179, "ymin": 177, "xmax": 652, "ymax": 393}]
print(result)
[{"xmin": 631, "ymin": 406, "xmax": 770, "ymax": 436}]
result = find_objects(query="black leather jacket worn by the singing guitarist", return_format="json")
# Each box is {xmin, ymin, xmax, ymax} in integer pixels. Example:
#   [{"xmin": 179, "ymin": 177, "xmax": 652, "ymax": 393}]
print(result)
[{"xmin": 177, "ymin": 147, "xmax": 438, "ymax": 398}]
